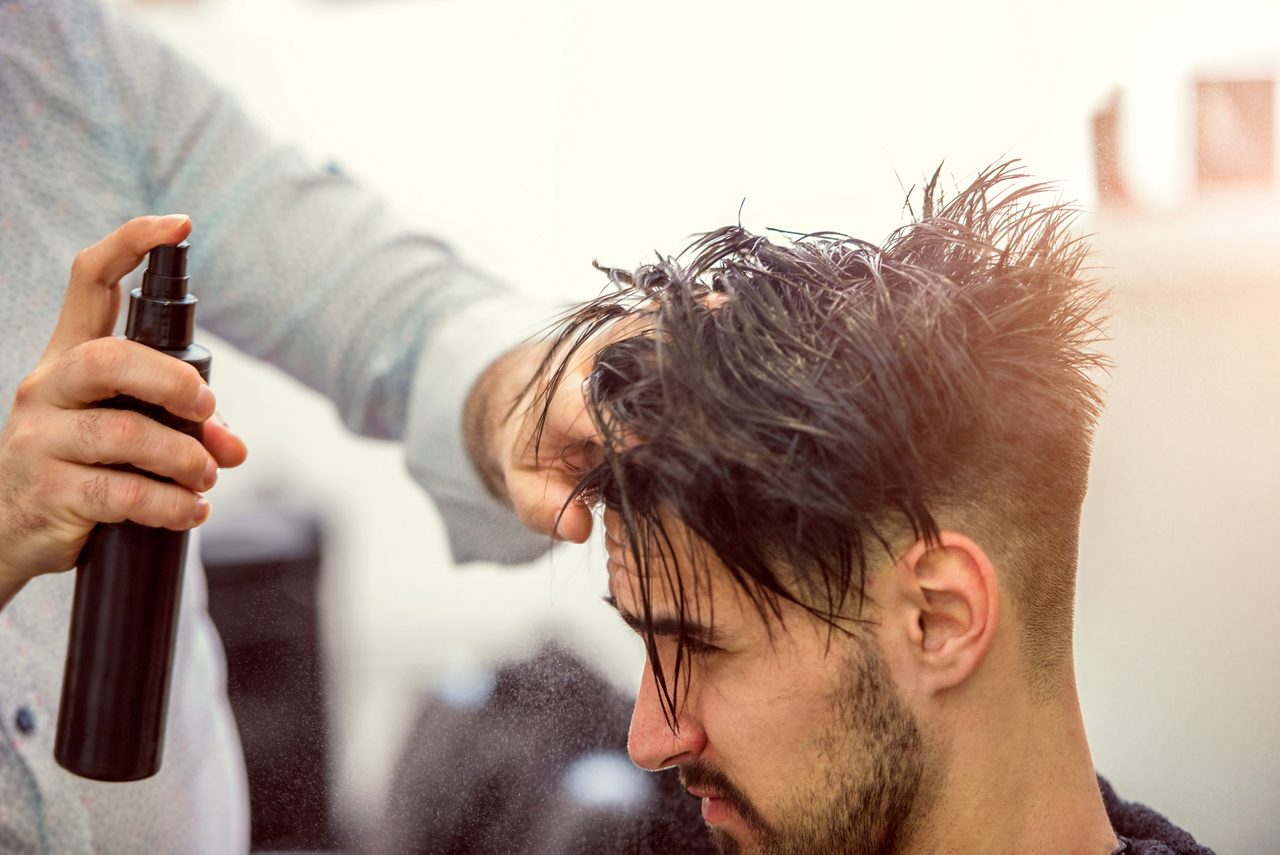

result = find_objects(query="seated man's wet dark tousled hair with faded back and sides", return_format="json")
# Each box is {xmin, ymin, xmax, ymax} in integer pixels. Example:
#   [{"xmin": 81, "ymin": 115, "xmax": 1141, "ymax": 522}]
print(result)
[{"xmin": 535, "ymin": 163, "xmax": 1103, "ymax": 722}]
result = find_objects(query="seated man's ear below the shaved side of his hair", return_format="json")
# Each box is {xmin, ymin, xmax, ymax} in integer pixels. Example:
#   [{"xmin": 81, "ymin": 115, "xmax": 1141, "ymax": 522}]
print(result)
[{"xmin": 884, "ymin": 531, "xmax": 1000, "ymax": 695}]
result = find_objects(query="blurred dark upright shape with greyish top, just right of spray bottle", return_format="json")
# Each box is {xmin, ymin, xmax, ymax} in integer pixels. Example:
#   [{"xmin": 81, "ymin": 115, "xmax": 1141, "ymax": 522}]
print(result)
[{"xmin": 201, "ymin": 503, "xmax": 337, "ymax": 850}]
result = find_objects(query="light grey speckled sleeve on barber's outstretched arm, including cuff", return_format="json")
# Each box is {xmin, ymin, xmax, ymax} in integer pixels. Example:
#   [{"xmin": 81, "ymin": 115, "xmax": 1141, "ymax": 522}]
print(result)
[{"xmin": 86, "ymin": 0, "xmax": 552, "ymax": 562}]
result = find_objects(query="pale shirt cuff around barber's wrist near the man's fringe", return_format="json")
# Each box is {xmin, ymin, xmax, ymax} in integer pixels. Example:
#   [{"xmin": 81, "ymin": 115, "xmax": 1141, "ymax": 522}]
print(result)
[{"xmin": 404, "ymin": 294, "xmax": 563, "ymax": 564}]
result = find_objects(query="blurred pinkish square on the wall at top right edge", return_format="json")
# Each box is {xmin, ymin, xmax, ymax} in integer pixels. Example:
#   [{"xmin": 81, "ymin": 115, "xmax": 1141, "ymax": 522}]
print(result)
[{"xmin": 1196, "ymin": 78, "xmax": 1276, "ymax": 189}]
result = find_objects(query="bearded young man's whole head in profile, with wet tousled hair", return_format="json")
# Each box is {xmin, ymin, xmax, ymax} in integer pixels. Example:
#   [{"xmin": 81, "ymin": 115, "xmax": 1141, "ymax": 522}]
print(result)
[{"xmin": 532, "ymin": 165, "xmax": 1101, "ymax": 851}]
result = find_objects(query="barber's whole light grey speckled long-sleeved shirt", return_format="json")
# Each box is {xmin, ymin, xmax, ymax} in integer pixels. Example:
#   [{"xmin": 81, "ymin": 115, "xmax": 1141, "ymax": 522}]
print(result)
[{"xmin": 0, "ymin": 0, "xmax": 545, "ymax": 855}]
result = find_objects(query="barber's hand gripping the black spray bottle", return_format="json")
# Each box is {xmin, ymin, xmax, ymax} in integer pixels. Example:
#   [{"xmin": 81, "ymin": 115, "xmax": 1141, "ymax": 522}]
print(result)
[{"xmin": 0, "ymin": 216, "xmax": 246, "ymax": 605}]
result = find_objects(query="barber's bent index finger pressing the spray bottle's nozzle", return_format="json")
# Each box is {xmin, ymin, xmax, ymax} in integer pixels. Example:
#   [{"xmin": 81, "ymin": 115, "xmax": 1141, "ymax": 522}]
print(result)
[{"xmin": 45, "ymin": 214, "xmax": 191, "ymax": 358}]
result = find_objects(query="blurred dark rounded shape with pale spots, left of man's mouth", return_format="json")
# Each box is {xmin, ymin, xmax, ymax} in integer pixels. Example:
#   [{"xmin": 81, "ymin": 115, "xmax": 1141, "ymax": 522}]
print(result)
[{"xmin": 370, "ymin": 644, "xmax": 714, "ymax": 855}]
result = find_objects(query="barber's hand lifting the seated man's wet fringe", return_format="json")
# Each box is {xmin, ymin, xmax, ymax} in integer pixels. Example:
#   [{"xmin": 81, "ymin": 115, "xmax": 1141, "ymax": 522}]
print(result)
[{"xmin": 465, "ymin": 343, "xmax": 599, "ymax": 543}]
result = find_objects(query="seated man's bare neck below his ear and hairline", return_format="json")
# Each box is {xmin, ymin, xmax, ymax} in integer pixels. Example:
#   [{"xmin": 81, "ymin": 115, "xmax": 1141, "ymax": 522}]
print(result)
[{"xmin": 904, "ymin": 686, "xmax": 1119, "ymax": 855}]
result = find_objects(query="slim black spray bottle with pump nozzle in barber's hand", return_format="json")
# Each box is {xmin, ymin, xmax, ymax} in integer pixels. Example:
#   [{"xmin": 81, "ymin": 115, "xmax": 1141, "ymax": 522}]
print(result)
[{"xmin": 54, "ymin": 241, "xmax": 210, "ymax": 781}]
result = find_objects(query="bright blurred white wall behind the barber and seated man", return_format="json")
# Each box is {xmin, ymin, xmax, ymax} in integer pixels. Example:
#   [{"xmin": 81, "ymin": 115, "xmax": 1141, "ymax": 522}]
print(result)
[{"xmin": 115, "ymin": 0, "xmax": 1280, "ymax": 854}]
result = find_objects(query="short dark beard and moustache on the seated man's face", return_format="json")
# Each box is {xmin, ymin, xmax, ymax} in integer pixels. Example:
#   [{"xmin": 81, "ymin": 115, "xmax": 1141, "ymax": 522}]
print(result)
[{"xmin": 680, "ymin": 644, "xmax": 925, "ymax": 855}]
